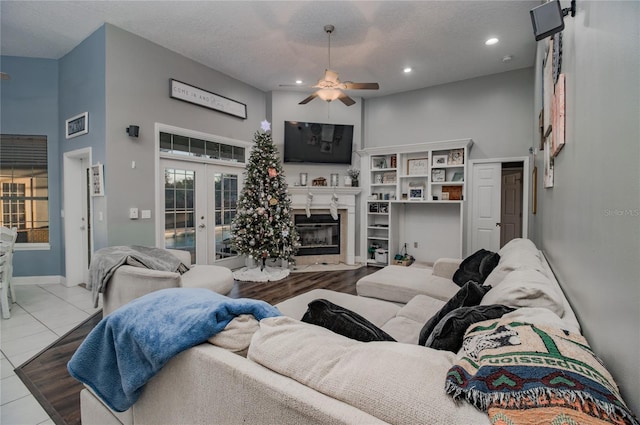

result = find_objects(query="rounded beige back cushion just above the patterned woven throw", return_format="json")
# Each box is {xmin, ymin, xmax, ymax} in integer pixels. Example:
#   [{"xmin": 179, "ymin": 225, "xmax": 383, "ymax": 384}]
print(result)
[{"xmin": 480, "ymin": 267, "xmax": 564, "ymax": 316}]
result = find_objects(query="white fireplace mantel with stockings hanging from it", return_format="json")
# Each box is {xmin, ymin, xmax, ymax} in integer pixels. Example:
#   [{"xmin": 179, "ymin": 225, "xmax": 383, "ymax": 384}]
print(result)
[{"xmin": 289, "ymin": 186, "xmax": 362, "ymax": 265}]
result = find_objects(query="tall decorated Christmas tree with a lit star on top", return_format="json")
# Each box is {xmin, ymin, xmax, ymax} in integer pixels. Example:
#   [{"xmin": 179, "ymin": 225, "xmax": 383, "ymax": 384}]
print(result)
[{"xmin": 231, "ymin": 121, "xmax": 299, "ymax": 270}]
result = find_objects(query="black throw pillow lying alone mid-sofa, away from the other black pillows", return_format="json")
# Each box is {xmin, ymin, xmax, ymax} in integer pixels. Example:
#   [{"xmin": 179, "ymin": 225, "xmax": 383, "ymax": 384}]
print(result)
[{"xmin": 302, "ymin": 299, "xmax": 395, "ymax": 342}]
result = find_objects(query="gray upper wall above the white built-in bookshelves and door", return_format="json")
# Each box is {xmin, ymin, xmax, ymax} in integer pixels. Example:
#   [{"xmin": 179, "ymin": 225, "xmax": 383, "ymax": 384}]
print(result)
[{"xmin": 364, "ymin": 68, "xmax": 534, "ymax": 159}]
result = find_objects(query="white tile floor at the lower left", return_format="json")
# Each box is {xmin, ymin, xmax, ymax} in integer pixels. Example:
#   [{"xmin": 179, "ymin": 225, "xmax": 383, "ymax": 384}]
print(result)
[{"xmin": 0, "ymin": 284, "xmax": 101, "ymax": 425}]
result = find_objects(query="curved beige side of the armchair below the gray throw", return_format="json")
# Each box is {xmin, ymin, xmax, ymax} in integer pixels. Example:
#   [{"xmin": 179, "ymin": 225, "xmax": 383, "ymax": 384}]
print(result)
[{"xmin": 102, "ymin": 265, "xmax": 180, "ymax": 316}]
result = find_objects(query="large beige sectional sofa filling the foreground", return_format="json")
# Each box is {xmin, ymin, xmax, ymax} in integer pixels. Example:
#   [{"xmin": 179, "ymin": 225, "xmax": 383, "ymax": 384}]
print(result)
[{"xmin": 81, "ymin": 239, "xmax": 636, "ymax": 425}]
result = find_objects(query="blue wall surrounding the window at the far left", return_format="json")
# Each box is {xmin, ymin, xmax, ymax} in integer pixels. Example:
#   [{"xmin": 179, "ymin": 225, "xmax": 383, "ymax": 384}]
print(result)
[{"xmin": 0, "ymin": 56, "xmax": 63, "ymax": 277}]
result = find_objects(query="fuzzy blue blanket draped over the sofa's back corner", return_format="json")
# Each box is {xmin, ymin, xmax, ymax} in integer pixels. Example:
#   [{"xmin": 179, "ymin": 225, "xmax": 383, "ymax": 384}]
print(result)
[{"xmin": 67, "ymin": 288, "xmax": 281, "ymax": 412}]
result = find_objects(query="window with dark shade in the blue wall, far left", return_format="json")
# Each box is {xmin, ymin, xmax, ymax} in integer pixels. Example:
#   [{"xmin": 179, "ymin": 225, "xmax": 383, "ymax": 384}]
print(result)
[{"xmin": 0, "ymin": 134, "xmax": 49, "ymax": 243}]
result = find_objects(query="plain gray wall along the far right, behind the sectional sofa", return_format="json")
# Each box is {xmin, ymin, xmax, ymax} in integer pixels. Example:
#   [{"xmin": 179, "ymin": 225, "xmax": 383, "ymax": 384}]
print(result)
[{"xmin": 531, "ymin": 1, "xmax": 640, "ymax": 414}]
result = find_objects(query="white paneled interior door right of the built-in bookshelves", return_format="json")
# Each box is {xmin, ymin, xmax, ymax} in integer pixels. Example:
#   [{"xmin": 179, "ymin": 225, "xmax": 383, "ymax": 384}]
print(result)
[{"xmin": 471, "ymin": 163, "xmax": 502, "ymax": 252}]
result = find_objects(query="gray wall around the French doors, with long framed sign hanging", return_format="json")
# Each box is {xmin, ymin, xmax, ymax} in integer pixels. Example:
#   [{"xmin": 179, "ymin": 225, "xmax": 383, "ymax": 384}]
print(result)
[{"xmin": 102, "ymin": 24, "xmax": 266, "ymax": 248}]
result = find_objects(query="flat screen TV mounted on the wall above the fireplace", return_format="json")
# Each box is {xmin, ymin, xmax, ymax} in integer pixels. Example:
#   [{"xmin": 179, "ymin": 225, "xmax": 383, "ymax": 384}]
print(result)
[{"xmin": 284, "ymin": 121, "xmax": 353, "ymax": 164}]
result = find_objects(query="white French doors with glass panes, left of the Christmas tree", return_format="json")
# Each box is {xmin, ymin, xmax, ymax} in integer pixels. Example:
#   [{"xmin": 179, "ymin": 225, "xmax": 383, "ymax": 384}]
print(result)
[{"xmin": 159, "ymin": 158, "xmax": 244, "ymax": 268}]
